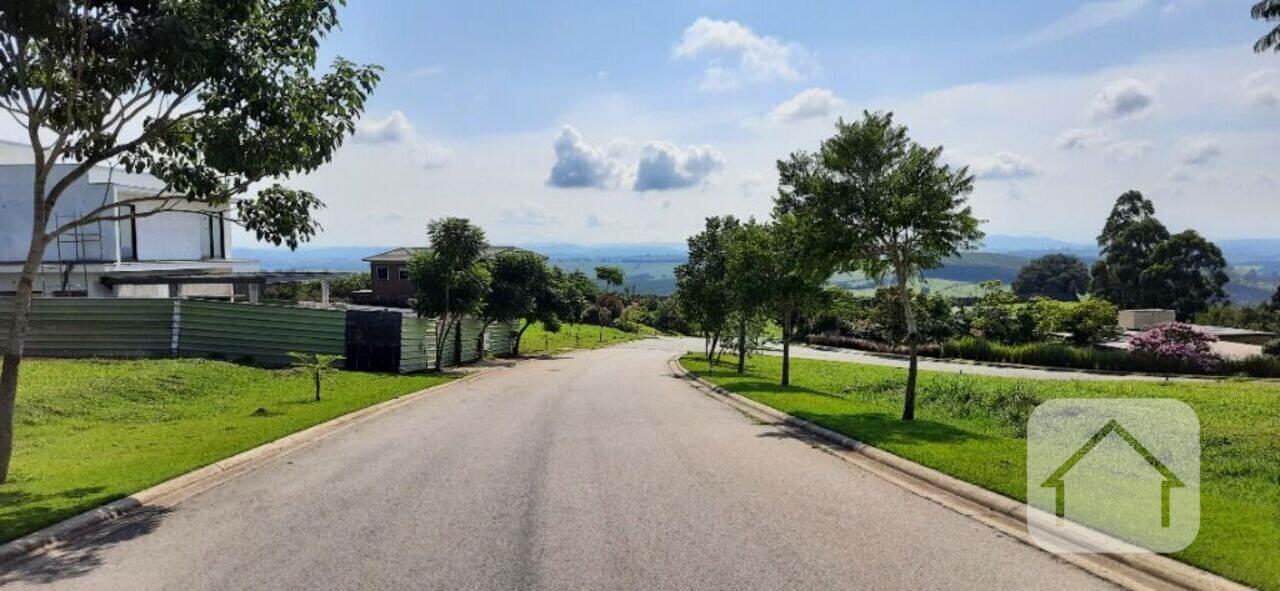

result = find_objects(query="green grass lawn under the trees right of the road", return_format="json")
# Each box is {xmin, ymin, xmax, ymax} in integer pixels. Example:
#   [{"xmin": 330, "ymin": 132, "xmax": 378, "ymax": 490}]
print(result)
[{"xmin": 681, "ymin": 354, "xmax": 1280, "ymax": 590}]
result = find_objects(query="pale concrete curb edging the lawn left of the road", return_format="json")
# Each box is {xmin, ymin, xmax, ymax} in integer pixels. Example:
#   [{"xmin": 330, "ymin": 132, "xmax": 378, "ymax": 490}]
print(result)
[{"xmin": 0, "ymin": 366, "xmax": 508, "ymax": 568}]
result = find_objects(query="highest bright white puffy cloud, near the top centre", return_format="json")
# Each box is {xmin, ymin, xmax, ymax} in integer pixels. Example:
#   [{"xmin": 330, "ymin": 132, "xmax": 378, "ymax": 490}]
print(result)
[{"xmin": 671, "ymin": 17, "xmax": 810, "ymax": 91}]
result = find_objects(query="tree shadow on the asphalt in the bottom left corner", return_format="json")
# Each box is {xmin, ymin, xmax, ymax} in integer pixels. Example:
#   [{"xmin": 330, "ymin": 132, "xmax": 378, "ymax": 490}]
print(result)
[{"xmin": 0, "ymin": 507, "xmax": 173, "ymax": 587}]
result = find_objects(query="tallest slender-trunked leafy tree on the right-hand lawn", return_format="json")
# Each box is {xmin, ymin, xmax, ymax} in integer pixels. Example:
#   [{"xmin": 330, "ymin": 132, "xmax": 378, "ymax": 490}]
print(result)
[{"xmin": 777, "ymin": 113, "xmax": 983, "ymax": 421}]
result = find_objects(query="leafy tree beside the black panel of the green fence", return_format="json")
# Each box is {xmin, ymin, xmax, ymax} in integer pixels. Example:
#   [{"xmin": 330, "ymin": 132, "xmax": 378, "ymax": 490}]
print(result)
[{"xmin": 408, "ymin": 217, "xmax": 490, "ymax": 370}]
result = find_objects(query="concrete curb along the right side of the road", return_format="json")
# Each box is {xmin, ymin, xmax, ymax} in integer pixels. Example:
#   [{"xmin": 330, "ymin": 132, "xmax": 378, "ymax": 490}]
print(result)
[{"xmin": 668, "ymin": 356, "xmax": 1252, "ymax": 591}]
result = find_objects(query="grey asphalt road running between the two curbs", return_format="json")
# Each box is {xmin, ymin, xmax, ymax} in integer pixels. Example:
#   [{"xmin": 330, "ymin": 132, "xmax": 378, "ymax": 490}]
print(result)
[{"xmin": 0, "ymin": 340, "xmax": 1108, "ymax": 591}]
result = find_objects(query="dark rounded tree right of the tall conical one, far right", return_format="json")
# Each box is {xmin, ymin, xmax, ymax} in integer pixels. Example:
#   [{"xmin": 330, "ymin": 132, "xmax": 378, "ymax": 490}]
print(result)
[{"xmin": 1140, "ymin": 230, "xmax": 1229, "ymax": 321}]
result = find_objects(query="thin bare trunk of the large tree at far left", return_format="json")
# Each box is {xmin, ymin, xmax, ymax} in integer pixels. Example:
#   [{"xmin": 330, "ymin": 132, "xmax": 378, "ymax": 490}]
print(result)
[{"xmin": 0, "ymin": 207, "xmax": 47, "ymax": 484}]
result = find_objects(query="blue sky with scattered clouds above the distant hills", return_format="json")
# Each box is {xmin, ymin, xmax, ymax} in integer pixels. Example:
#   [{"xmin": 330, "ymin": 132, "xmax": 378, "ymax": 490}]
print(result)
[{"xmin": 241, "ymin": 0, "xmax": 1280, "ymax": 244}]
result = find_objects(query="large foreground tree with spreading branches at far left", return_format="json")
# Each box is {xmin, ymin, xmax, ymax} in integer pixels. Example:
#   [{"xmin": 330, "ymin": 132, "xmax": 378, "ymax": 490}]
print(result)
[{"xmin": 0, "ymin": 0, "xmax": 379, "ymax": 482}]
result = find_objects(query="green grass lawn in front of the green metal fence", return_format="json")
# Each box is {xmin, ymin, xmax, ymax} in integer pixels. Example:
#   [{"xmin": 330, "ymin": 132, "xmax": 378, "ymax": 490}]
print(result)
[{"xmin": 0, "ymin": 359, "xmax": 451, "ymax": 542}]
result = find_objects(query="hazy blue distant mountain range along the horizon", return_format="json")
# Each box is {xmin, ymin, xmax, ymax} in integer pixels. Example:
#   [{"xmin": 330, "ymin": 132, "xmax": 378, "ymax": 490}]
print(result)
[{"xmin": 236, "ymin": 234, "xmax": 1280, "ymax": 303}]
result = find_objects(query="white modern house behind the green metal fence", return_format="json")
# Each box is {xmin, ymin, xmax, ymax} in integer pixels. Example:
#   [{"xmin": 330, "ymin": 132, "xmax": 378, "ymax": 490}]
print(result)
[{"xmin": 0, "ymin": 141, "xmax": 259, "ymax": 298}]
